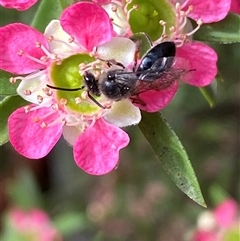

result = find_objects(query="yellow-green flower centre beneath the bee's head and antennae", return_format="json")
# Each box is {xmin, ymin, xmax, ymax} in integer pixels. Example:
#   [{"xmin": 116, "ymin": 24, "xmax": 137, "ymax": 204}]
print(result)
[{"xmin": 49, "ymin": 54, "xmax": 110, "ymax": 115}]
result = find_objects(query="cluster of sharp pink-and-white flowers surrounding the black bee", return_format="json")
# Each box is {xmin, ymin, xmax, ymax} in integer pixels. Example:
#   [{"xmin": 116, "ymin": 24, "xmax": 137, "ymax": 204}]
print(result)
[{"xmin": 0, "ymin": 0, "xmax": 230, "ymax": 175}]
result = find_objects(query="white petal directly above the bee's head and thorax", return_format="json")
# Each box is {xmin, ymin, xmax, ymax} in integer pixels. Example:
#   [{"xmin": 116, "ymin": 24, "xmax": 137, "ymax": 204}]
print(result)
[{"xmin": 97, "ymin": 37, "xmax": 136, "ymax": 67}]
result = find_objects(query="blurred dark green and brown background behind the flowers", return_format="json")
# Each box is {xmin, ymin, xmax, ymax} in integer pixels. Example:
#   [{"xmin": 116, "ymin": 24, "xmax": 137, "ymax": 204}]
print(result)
[{"xmin": 0, "ymin": 5, "xmax": 240, "ymax": 241}]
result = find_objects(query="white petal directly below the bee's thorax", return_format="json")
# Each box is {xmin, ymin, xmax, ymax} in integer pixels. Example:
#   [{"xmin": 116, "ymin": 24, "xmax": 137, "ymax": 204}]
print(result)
[{"xmin": 104, "ymin": 99, "xmax": 141, "ymax": 127}]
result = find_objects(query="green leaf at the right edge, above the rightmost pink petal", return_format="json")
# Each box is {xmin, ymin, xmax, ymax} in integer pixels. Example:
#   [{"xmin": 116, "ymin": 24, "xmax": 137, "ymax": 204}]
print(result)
[{"xmin": 193, "ymin": 13, "xmax": 240, "ymax": 44}]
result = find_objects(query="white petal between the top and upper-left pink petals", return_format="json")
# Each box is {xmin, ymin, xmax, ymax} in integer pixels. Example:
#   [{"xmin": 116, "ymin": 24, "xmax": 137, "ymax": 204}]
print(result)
[{"xmin": 44, "ymin": 20, "xmax": 79, "ymax": 55}]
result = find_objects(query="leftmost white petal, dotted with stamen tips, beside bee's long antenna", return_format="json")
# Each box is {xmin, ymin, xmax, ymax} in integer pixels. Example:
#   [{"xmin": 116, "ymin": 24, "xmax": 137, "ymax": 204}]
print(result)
[{"xmin": 17, "ymin": 71, "xmax": 52, "ymax": 104}]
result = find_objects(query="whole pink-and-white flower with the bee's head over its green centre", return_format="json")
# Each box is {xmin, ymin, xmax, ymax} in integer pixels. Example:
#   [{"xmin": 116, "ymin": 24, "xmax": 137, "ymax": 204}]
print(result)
[{"xmin": 0, "ymin": 2, "xmax": 141, "ymax": 175}]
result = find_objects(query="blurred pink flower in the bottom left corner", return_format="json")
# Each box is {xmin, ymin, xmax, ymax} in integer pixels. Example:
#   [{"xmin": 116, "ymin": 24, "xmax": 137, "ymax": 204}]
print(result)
[{"xmin": 8, "ymin": 208, "xmax": 60, "ymax": 241}]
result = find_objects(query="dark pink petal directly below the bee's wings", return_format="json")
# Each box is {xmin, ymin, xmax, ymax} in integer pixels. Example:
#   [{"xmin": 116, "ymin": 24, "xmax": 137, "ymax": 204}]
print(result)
[{"xmin": 133, "ymin": 82, "xmax": 178, "ymax": 112}]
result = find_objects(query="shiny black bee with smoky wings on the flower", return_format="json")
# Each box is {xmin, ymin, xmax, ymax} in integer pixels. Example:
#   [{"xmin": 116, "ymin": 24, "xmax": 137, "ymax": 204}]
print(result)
[{"xmin": 48, "ymin": 42, "xmax": 192, "ymax": 108}]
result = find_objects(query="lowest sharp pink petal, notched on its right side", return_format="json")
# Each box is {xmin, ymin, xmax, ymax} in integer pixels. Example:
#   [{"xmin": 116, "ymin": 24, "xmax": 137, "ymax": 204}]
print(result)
[{"xmin": 73, "ymin": 119, "xmax": 129, "ymax": 175}]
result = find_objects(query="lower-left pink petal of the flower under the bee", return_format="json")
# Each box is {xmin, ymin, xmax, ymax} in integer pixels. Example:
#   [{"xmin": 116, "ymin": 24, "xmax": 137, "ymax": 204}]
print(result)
[{"xmin": 8, "ymin": 107, "xmax": 62, "ymax": 159}]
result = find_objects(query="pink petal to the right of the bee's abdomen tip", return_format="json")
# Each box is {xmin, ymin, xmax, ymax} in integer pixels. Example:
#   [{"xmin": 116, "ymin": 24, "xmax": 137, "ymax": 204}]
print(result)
[{"xmin": 176, "ymin": 42, "xmax": 218, "ymax": 87}]
